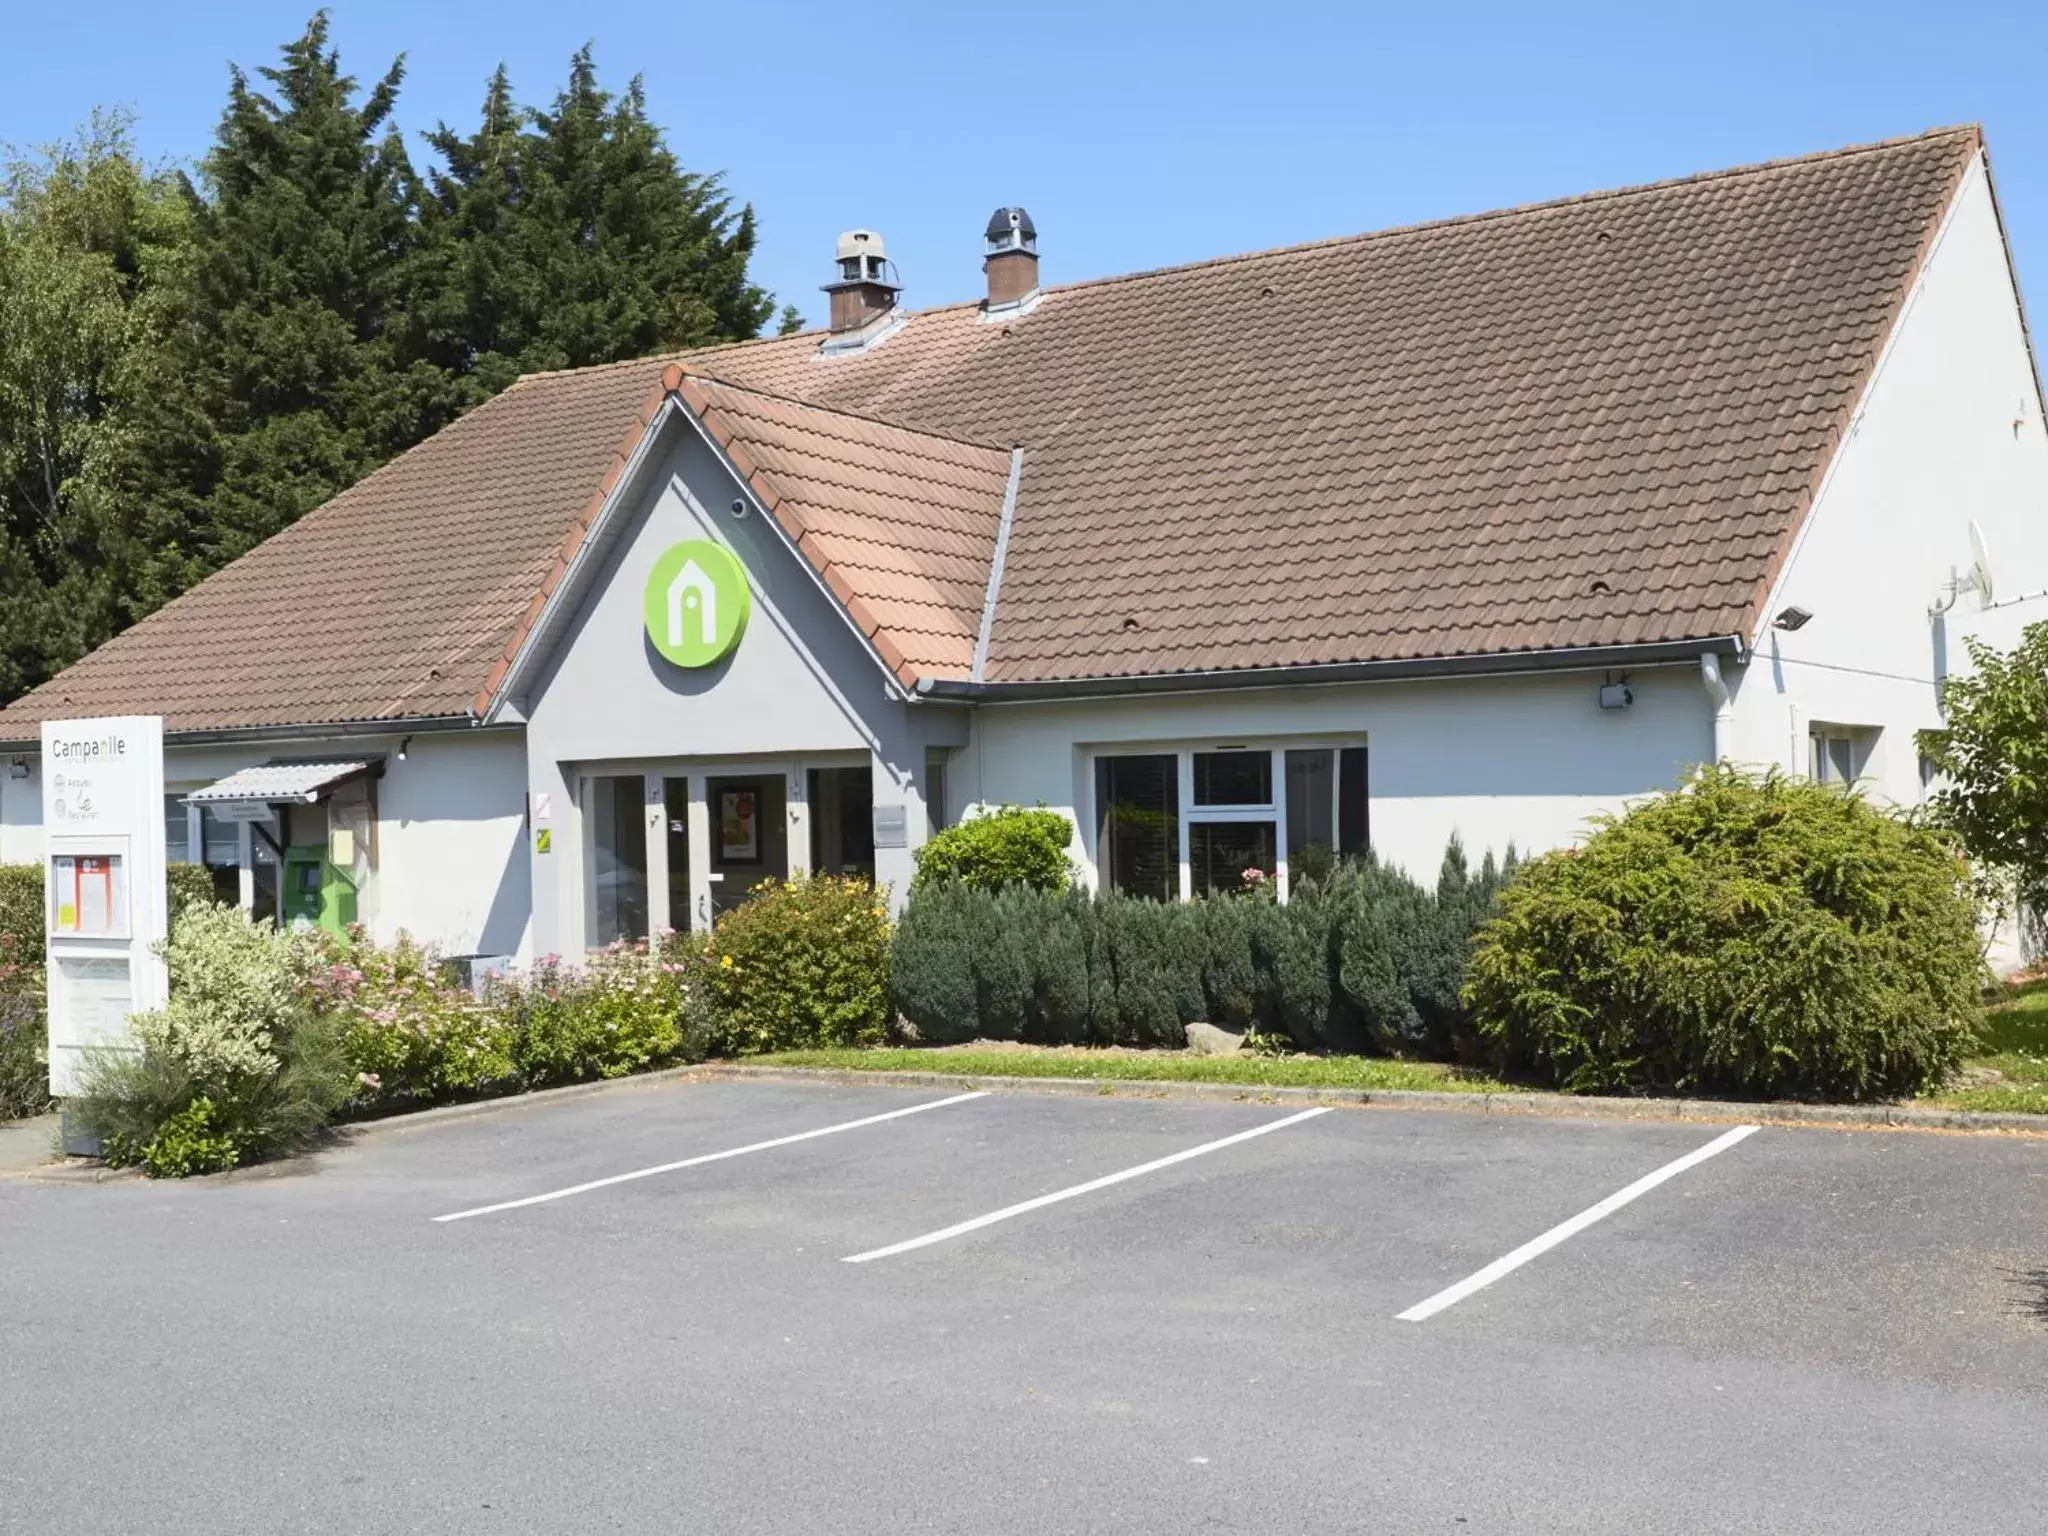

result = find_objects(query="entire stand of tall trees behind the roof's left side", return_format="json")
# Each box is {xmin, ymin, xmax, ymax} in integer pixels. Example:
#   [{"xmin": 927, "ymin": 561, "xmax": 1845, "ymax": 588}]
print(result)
[{"xmin": 0, "ymin": 12, "xmax": 791, "ymax": 700}]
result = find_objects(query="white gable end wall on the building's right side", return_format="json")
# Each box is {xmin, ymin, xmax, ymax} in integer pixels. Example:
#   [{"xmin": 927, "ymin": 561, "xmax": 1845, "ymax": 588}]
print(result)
[{"xmin": 1729, "ymin": 160, "xmax": 2048, "ymax": 805}]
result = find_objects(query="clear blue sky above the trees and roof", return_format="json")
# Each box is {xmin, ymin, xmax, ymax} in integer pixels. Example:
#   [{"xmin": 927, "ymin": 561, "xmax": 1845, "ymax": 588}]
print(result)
[{"xmin": 0, "ymin": 0, "xmax": 2048, "ymax": 332}]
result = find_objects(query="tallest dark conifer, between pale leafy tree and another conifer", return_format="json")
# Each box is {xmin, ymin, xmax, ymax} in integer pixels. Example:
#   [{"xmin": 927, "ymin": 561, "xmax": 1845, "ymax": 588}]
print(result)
[{"xmin": 133, "ymin": 12, "xmax": 457, "ymax": 593}]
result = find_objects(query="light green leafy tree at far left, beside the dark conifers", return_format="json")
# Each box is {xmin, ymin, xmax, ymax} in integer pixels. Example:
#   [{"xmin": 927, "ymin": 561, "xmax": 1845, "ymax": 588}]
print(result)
[{"xmin": 0, "ymin": 113, "xmax": 190, "ymax": 698}]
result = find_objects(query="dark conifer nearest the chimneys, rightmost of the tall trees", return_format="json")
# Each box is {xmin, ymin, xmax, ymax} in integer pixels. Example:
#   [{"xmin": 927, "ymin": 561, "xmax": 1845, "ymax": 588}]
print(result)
[{"xmin": 420, "ymin": 47, "xmax": 774, "ymax": 391}]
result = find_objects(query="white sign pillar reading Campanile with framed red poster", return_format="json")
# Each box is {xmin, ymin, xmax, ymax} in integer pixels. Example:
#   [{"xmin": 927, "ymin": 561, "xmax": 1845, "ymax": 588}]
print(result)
[{"xmin": 43, "ymin": 715, "xmax": 170, "ymax": 1098}]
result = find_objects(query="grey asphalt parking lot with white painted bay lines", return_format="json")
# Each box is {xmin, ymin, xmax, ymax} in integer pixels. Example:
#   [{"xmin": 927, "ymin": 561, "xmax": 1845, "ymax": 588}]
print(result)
[{"xmin": 0, "ymin": 1081, "xmax": 2048, "ymax": 1536}]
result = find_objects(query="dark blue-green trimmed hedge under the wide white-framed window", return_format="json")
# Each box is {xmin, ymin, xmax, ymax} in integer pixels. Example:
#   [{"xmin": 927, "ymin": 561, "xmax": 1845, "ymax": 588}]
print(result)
[{"xmin": 891, "ymin": 840, "xmax": 1513, "ymax": 1057}]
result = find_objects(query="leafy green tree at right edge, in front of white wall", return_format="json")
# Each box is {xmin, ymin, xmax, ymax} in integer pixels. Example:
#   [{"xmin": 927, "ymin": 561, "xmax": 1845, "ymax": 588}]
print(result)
[{"xmin": 1919, "ymin": 623, "xmax": 2048, "ymax": 905}]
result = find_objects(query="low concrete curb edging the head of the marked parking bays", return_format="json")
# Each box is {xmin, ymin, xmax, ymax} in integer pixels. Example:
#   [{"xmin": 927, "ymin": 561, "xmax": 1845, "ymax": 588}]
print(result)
[{"xmin": 688, "ymin": 1063, "xmax": 2048, "ymax": 1137}]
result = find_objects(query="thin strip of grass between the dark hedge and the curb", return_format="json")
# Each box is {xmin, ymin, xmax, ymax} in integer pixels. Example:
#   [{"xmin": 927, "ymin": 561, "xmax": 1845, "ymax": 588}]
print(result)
[{"xmin": 754, "ymin": 1047, "xmax": 1520, "ymax": 1094}]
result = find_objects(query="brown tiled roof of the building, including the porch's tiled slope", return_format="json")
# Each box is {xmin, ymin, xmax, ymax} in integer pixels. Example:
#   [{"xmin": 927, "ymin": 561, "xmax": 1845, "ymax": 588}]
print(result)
[{"xmin": 0, "ymin": 129, "xmax": 1980, "ymax": 739}]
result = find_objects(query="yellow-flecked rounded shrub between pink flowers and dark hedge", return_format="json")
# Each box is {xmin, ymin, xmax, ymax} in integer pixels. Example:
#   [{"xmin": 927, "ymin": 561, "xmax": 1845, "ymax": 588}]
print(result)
[{"xmin": 707, "ymin": 874, "xmax": 889, "ymax": 1053}]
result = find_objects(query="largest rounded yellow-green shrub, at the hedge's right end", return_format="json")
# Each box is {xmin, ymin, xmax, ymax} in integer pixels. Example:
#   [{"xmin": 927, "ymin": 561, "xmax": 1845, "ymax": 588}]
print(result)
[{"xmin": 1464, "ymin": 768, "xmax": 1985, "ymax": 1100}]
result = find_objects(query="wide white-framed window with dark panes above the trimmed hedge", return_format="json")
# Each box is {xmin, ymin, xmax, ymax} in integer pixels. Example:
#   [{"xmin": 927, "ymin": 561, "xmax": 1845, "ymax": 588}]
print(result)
[{"xmin": 1096, "ymin": 741, "xmax": 1368, "ymax": 901}]
